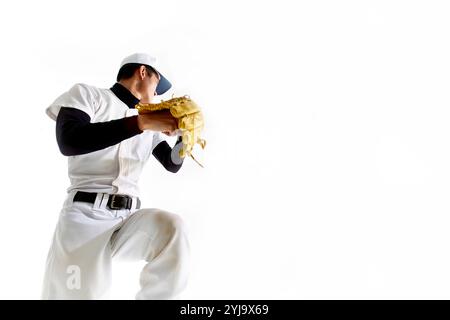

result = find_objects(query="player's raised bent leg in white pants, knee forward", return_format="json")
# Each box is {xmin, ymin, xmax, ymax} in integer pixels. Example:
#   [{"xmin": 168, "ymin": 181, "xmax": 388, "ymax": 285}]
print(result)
[{"xmin": 111, "ymin": 209, "xmax": 189, "ymax": 300}]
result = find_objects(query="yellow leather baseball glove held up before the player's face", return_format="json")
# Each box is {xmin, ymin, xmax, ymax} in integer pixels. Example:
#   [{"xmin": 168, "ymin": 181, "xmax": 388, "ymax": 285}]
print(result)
[{"xmin": 135, "ymin": 95, "xmax": 206, "ymax": 167}]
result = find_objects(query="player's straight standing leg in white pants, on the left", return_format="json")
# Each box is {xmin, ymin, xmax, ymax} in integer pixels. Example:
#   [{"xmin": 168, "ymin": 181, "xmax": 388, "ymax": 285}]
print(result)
[{"xmin": 42, "ymin": 202, "xmax": 121, "ymax": 299}]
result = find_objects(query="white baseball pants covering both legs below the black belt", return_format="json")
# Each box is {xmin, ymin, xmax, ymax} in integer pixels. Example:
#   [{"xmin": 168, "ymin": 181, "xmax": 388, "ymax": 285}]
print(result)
[{"xmin": 42, "ymin": 191, "xmax": 189, "ymax": 299}]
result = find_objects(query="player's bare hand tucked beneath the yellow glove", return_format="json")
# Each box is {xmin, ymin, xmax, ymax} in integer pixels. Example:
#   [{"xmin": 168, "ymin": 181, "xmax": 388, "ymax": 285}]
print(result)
[{"xmin": 138, "ymin": 110, "xmax": 178, "ymax": 135}]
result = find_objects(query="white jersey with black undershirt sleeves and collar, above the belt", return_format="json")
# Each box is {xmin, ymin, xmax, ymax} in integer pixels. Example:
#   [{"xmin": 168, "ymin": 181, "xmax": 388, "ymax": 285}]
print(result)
[{"xmin": 46, "ymin": 83, "xmax": 183, "ymax": 197}]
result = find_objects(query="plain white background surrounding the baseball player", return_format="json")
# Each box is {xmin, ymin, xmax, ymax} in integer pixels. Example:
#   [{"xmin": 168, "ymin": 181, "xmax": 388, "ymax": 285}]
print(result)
[{"xmin": 0, "ymin": 0, "xmax": 450, "ymax": 299}]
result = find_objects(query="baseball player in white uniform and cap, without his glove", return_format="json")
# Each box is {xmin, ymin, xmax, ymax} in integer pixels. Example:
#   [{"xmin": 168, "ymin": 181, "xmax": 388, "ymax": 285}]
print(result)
[{"xmin": 42, "ymin": 53, "xmax": 189, "ymax": 299}]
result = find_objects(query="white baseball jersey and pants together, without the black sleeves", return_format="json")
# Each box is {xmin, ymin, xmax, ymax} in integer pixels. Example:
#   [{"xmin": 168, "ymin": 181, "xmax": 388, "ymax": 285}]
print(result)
[{"xmin": 42, "ymin": 84, "xmax": 189, "ymax": 299}]
